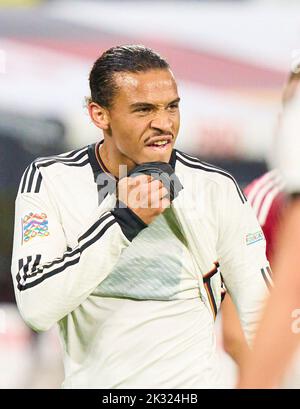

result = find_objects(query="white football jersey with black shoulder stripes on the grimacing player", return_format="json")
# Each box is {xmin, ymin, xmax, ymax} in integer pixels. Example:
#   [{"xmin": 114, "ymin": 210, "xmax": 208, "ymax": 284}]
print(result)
[{"xmin": 12, "ymin": 144, "xmax": 270, "ymax": 388}]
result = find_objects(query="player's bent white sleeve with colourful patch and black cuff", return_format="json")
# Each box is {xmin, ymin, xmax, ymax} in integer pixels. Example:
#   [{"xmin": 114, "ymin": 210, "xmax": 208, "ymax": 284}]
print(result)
[{"xmin": 12, "ymin": 164, "xmax": 146, "ymax": 331}]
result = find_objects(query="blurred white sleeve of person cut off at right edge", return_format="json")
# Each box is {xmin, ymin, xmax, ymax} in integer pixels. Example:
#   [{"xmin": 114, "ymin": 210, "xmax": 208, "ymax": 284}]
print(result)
[{"xmin": 274, "ymin": 93, "xmax": 300, "ymax": 193}]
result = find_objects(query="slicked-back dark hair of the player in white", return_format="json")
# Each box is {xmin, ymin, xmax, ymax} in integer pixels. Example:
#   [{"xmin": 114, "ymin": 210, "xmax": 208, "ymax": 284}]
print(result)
[{"xmin": 89, "ymin": 45, "xmax": 169, "ymax": 108}]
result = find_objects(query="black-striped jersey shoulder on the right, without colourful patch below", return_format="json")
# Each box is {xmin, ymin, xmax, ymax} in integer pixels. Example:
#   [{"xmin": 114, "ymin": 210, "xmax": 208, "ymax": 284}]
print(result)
[{"xmin": 176, "ymin": 149, "xmax": 247, "ymax": 203}]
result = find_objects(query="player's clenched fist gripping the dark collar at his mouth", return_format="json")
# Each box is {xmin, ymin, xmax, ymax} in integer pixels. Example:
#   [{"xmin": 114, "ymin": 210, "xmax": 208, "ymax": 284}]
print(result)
[{"xmin": 118, "ymin": 175, "xmax": 170, "ymax": 224}]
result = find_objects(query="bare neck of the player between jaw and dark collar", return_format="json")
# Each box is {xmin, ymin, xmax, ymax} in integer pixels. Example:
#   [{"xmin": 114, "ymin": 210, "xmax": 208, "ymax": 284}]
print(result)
[{"xmin": 99, "ymin": 139, "xmax": 136, "ymax": 178}]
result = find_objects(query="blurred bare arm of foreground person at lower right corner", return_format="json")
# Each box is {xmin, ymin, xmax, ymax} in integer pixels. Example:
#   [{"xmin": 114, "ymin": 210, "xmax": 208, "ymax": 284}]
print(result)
[{"xmin": 238, "ymin": 199, "xmax": 300, "ymax": 388}]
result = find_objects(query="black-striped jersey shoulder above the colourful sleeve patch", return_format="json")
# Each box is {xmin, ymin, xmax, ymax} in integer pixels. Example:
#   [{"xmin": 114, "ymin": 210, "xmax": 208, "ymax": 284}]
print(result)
[{"xmin": 19, "ymin": 146, "xmax": 89, "ymax": 193}]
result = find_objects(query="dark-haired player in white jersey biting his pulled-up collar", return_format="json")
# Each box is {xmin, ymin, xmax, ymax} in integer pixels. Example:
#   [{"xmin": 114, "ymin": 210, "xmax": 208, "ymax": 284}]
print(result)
[{"xmin": 12, "ymin": 45, "xmax": 270, "ymax": 388}]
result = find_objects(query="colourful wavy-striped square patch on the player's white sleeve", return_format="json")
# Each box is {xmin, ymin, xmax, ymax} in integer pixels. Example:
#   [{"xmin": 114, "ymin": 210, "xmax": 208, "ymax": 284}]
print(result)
[{"xmin": 21, "ymin": 212, "xmax": 49, "ymax": 243}]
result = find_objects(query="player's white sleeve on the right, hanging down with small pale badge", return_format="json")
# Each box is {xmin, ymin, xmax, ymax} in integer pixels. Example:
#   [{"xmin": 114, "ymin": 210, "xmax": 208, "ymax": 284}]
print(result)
[{"xmin": 218, "ymin": 180, "xmax": 272, "ymax": 342}]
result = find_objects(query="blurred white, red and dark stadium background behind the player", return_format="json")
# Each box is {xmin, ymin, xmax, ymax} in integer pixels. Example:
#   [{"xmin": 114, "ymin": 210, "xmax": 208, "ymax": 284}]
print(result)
[{"xmin": 0, "ymin": 0, "xmax": 300, "ymax": 388}]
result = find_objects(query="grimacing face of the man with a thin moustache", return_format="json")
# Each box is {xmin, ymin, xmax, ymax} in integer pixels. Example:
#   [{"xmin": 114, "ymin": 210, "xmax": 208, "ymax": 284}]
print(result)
[{"xmin": 108, "ymin": 69, "xmax": 180, "ymax": 164}]
